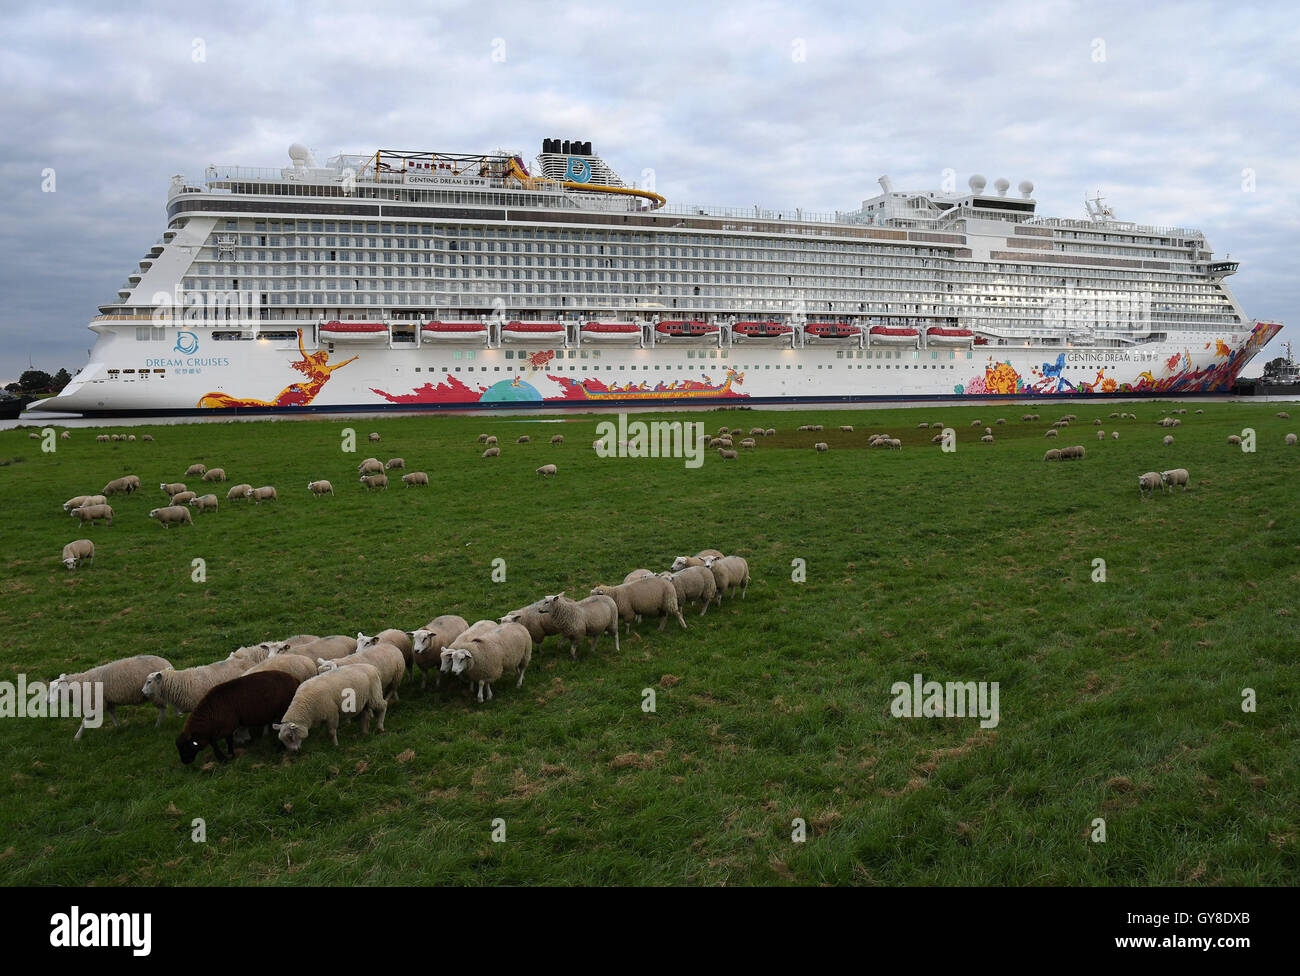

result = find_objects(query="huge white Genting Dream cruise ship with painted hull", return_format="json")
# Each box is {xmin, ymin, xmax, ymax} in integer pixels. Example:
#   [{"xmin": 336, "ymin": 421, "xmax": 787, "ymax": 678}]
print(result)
[{"xmin": 34, "ymin": 138, "xmax": 1281, "ymax": 416}]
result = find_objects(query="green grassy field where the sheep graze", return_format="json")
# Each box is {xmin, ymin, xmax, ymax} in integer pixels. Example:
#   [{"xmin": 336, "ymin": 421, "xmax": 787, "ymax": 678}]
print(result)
[{"xmin": 0, "ymin": 403, "xmax": 1300, "ymax": 885}]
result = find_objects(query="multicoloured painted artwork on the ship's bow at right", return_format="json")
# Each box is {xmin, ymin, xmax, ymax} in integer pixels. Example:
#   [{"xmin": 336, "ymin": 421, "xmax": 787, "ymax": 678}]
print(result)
[{"xmin": 953, "ymin": 322, "xmax": 1282, "ymax": 396}]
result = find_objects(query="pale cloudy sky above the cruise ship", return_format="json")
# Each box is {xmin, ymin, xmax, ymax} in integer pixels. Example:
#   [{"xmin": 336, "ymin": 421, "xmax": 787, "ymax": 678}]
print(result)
[{"xmin": 0, "ymin": 0, "xmax": 1300, "ymax": 379}]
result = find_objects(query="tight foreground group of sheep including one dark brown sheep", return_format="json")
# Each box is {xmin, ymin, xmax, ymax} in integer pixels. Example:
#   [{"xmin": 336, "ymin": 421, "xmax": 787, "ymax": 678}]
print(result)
[{"xmin": 48, "ymin": 550, "xmax": 750, "ymax": 764}]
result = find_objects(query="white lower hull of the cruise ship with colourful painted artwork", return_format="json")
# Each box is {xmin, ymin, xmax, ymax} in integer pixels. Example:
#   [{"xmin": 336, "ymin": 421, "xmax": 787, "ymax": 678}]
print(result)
[{"xmin": 34, "ymin": 322, "xmax": 1281, "ymax": 416}]
